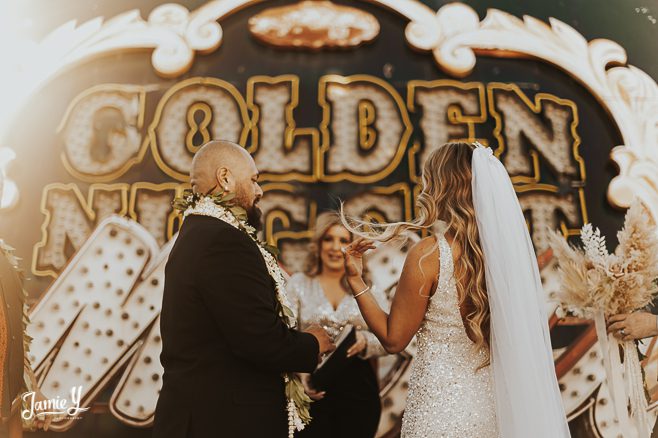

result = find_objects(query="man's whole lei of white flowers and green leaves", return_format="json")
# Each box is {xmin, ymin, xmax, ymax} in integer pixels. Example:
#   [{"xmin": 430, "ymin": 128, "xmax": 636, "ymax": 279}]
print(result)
[{"xmin": 173, "ymin": 189, "xmax": 311, "ymax": 438}]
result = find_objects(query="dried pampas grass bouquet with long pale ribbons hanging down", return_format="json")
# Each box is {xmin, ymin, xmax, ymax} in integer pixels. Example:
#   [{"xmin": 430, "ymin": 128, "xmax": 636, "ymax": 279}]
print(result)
[{"xmin": 549, "ymin": 201, "xmax": 658, "ymax": 437}]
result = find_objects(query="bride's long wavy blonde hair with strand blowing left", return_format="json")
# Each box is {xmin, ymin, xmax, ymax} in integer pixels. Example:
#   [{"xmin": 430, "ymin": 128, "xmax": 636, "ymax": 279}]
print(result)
[{"xmin": 341, "ymin": 143, "xmax": 490, "ymax": 366}]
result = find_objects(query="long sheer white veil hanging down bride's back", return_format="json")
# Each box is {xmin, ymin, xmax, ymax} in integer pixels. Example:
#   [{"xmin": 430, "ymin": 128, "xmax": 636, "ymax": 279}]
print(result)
[{"xmin": 472, "ymin": 144, "xmax": 570, "ymax": 438}]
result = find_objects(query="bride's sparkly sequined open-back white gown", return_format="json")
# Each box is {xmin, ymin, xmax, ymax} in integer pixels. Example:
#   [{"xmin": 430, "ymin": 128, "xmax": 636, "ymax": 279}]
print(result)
[{"xmin": 401, "ymin": 234, "xmax": 499, "ymax": 438}]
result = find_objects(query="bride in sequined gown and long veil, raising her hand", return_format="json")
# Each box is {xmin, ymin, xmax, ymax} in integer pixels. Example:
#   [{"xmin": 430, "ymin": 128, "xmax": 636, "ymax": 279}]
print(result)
[{"xmin": 342, "ymin": 143, "xmax": 570, "ymax": 438}]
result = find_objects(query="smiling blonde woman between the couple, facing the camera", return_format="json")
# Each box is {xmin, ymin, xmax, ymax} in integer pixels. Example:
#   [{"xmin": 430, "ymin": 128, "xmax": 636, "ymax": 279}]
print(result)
[{"xmin": 286, "ymin": 212, "xmax": 388, "ymax": 438}]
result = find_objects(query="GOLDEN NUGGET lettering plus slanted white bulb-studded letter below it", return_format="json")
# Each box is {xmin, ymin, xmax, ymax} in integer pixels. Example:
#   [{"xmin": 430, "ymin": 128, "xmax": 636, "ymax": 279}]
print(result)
[{"xmin": 29, "ymin": 75, "xmax": 584, "ymax": 430}]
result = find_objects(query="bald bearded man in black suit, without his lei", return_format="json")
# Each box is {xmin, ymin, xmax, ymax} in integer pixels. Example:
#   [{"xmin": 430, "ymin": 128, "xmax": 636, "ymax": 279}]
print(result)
[{"xmin": 153, "ymin": 141, "xmax": 334, "ymax": 438}]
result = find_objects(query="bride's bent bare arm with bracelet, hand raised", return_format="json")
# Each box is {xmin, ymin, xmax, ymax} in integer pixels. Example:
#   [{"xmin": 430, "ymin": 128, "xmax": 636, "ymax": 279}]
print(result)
[{"xmin": 345, "ymin": 237, "xmax": 439, "ymax": 353}]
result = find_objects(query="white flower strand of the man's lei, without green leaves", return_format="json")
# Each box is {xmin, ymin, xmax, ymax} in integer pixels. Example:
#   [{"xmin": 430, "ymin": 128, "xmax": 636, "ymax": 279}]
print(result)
[{"xmin": 183, "ymin": 197, "xmax": 306, "ymax": 438}]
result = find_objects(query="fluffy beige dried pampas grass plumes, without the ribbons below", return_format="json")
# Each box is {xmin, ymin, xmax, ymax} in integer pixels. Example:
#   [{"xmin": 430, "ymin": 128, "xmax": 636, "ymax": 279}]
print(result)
[{"xmin": 549, "ymin": 201, "xmax": 658, "ymax": 318}]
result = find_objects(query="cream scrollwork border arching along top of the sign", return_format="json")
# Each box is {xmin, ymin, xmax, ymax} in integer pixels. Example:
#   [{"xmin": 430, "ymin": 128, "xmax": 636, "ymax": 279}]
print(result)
[{"xmin": 0, "ymin": 0, "xmax": 658, "ymax": 218}]
